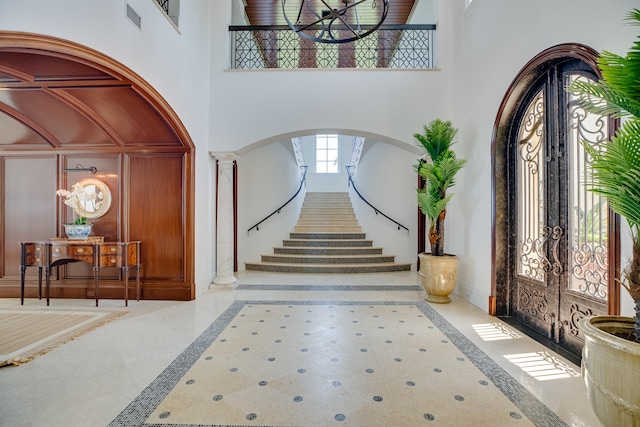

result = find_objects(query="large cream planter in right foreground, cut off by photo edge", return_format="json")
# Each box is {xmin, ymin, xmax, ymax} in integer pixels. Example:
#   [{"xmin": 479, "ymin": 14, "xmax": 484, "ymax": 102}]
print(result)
[{"xmin": 580, "ymin": 316, "xmax": 640, "ymax": 427}]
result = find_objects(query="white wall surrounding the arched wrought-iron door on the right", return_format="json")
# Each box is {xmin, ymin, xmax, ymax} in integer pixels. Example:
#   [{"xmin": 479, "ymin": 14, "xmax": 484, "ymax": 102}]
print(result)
[{"xmin": 450, "ymin": 0, "xmax": 638, "ymax": 310}]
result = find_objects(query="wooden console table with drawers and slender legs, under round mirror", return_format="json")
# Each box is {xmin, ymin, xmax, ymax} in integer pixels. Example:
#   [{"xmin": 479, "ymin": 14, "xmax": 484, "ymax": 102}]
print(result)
[{"xmin": 20, "ymin": 238, "xmax": 141, "ymax": 307}]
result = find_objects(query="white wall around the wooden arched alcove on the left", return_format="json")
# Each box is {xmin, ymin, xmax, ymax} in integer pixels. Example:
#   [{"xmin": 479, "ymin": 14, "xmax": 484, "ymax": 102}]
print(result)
[{"xmin": 0, "ymin": 0, "xmax": 216, "ymax": 292}]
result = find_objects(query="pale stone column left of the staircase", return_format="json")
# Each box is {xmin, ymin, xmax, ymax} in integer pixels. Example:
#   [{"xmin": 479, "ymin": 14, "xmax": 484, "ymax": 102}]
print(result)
[{"xmin": 211, "ymin": 152, "xmax": 238, "ymax": 286}]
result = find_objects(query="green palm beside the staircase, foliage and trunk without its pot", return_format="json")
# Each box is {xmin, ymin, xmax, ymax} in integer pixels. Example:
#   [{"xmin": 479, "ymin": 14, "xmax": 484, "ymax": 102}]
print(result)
[{"xmin": 413, "ymin": 119, "xmax": 466, "ymax": 256}]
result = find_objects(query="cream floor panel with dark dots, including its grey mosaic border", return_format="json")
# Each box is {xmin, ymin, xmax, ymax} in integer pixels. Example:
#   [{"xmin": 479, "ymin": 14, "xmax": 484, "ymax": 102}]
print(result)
[{"xmin": 110, "ymin": 301, "xmax": 566, "ymax": 427}]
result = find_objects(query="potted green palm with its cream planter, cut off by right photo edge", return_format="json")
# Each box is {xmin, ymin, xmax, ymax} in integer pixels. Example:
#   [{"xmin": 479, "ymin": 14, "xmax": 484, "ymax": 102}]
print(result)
[{"xmin": 567, "ymin": 9, "xmax": 640, "ymax": 427}]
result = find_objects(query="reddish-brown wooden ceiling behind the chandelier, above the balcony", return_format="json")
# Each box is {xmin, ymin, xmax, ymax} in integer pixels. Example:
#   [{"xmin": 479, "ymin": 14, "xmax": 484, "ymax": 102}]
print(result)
[{"xmin": 245, "ymin": 0, "xmax": 415, "ymax": 25}]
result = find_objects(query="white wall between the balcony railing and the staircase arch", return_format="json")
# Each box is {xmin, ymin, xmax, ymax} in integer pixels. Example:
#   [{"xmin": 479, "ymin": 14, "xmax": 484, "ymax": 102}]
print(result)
[{"xmin": 210, "ymin": 0, "xmax": 450, "ymax": 151}]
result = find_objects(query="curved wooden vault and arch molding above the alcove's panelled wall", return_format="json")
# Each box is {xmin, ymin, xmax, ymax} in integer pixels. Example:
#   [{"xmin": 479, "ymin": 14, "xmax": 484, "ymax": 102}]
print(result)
[{"xmin": 0, "ymin": 31, "xmax": 193, "ymax": 149}]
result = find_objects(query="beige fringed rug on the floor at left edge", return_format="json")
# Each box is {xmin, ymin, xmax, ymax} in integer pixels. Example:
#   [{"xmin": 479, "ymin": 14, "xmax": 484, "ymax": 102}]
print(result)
[{"xmin": 0, "ymin": 309, "xmax": 127, "ymax": 366}]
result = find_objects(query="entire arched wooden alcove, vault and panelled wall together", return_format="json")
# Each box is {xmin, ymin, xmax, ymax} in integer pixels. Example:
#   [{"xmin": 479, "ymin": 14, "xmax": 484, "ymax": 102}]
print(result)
[{"xmin": 0, "ymin": 31, "xmax": 195, "ymax": 300}]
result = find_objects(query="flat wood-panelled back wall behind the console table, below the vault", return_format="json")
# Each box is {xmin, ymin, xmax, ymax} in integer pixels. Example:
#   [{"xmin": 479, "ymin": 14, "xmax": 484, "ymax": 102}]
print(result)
[{"xmin": 0, "ymin": 152, "xmax": 195, "ymax": 300}]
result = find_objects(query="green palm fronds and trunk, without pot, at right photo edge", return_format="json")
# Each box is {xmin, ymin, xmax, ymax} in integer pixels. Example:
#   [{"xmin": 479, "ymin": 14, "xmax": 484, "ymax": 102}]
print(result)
[{"xmin": 567, "ymin": 9, "xmax": 640, "ymax": 342}]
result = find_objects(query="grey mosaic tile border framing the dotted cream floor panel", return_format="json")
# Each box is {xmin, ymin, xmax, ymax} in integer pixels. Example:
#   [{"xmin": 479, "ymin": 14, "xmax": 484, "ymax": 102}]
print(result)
[{"xmin": 109, "ymin": 300, "xmax": 567, "ymax": 427}]
